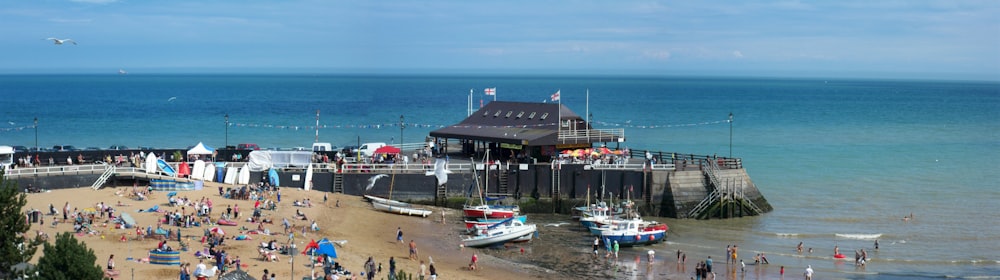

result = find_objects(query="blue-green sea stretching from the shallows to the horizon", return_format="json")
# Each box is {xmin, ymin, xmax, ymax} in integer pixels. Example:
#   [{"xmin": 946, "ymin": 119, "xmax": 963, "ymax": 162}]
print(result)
[{"xmin": 0, "ymin": 74, "xmax": 1000, "ymax": 279}]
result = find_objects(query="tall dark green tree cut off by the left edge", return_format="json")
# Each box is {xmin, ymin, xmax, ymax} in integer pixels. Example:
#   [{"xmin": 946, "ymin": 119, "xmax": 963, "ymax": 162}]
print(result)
[{"xmin": 0, "ymin": 171, "xmax": 40, "ymax": 279}]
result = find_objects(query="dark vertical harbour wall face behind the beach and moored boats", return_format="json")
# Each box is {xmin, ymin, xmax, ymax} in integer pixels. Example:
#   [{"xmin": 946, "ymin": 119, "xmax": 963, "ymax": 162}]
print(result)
[{"xmin": 5, "ymin": 164, "xmax": 772, "ymax": 218}]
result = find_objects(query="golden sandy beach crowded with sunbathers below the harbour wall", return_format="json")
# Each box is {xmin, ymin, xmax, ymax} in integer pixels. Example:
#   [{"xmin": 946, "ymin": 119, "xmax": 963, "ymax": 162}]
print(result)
[{"xmin": 19, "ymin": 184, "xmax": 547, "ymax": 279}]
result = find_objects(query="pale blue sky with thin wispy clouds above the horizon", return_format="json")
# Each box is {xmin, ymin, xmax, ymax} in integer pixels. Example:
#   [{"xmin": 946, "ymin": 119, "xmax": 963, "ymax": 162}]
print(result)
[{"xmin": 0, "ymin": 0, "xmax": 1000, "ymax": 80}]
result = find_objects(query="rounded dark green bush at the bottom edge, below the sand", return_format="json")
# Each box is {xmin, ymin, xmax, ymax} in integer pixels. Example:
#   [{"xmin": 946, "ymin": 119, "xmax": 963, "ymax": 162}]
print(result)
[{"xmin": 35, "ymin": 232, "xmax": 104, "ymax": 280}]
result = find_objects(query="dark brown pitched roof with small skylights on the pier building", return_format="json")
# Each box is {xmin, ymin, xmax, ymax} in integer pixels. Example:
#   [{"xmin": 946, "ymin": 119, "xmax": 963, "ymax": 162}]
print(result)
[{"xmin": 430, "ymin": 101, "xmax": 582, "ymax": 146}]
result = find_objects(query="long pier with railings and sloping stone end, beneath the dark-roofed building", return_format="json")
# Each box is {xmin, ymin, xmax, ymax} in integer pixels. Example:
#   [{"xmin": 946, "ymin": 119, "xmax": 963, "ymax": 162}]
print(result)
[{"xmin": 5, "ymin": 150, "xmax": 772, "ymax": 219}]
